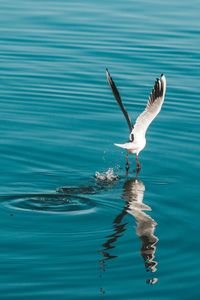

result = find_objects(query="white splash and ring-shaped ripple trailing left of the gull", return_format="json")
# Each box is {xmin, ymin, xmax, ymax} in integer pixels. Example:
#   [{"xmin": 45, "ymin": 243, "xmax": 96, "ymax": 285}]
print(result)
[{"xmin": 0, "ymin": 172, "xmax": 119, "ymax": 214}]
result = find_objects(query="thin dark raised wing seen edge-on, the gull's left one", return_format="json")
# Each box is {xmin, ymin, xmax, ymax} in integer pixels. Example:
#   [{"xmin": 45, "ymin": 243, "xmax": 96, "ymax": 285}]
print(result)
[{"xmin": 106, "ymin": 69, "xmax": 133, "ymax": 132}]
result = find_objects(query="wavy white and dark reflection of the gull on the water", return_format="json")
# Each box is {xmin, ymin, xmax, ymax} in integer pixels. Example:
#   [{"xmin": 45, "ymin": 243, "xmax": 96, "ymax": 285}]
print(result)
[{"xmin": 100, "ymin": 179, "xmax": 158, "ymax": 284}]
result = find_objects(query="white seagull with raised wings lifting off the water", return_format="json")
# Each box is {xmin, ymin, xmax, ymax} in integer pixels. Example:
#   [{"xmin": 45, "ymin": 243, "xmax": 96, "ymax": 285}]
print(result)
[{"xmin": 106, "ymin": 69, "xmax": 166, "ymax": 176}]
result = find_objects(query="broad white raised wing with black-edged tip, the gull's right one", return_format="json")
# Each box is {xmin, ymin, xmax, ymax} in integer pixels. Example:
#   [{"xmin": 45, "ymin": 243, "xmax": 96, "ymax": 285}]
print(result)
[{"xmin": 131, "ymin": 74, "xmax": 166, "ymax": 139}]
